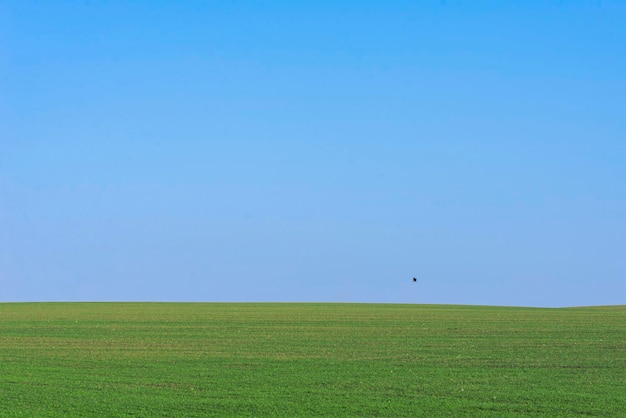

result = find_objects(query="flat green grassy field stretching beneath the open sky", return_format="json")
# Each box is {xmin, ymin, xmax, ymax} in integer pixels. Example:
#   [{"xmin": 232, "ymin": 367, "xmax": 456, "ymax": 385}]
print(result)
[{"xmin": 0, "ymin": 303, "xmax": 626, "ymax": 417}]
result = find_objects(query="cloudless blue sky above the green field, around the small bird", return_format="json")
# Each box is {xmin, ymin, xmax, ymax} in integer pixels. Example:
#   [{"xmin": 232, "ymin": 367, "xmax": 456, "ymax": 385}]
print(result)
[{"xmin": 0, "ymin": 0, "xmax": 626, "ymax": 307}]
